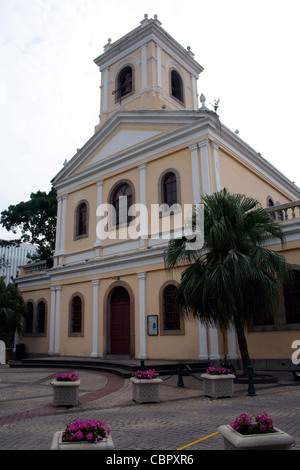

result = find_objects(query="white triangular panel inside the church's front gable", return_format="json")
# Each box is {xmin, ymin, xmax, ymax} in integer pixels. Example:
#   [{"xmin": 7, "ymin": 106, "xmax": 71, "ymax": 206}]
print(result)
[{"xmin": 89, "ymin": 129, "xmax": 161, "ymax": 165}]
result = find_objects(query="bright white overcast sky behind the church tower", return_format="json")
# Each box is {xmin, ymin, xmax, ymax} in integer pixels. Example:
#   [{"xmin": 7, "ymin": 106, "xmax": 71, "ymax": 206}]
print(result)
[{"xmin": 0, "ymin": 0, "xmax": 300, "ymax": 239}]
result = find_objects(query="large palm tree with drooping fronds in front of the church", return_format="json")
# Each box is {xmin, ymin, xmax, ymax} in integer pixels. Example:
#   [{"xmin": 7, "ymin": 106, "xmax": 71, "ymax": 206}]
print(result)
[{"xmin": 165, "ymin": 189, "xmax": 291, "ymax": 372}]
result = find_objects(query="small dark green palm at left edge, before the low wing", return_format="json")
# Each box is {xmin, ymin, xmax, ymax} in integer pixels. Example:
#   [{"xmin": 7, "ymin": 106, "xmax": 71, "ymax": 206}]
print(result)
[{"xmin": 0, "ymin": 277, "xmax": 27, "ymax": 346}]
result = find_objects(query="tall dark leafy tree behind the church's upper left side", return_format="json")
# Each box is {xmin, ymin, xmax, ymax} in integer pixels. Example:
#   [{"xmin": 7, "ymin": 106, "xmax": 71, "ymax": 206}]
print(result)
[{"xmin": 0, "ymin": 188, "xmax": 57, "ymax": 260}]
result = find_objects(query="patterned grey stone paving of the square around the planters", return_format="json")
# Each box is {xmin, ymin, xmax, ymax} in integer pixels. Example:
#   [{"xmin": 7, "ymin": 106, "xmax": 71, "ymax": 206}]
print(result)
[{"xmin": 0, "ymin": 365, "xmax": 300, "ymax": 453}]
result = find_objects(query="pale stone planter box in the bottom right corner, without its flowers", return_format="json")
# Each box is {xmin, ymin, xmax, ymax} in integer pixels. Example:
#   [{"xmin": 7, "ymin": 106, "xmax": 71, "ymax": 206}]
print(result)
[{"xmin": 218, "ymin": 424, "xmax": 295, "ymax": 450}]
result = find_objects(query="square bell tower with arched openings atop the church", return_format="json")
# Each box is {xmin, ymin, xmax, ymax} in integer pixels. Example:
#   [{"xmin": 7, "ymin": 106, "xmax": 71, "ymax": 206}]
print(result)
[{"xmin": 94, "ymin": 15, "xmax": 203, "ymax": 131}]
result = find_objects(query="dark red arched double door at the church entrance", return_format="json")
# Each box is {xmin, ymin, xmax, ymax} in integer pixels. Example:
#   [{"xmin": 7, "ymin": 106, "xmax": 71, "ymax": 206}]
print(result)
[{"xmin": 110, "ymin": 286, "xmax": 131, "ymax": 355}]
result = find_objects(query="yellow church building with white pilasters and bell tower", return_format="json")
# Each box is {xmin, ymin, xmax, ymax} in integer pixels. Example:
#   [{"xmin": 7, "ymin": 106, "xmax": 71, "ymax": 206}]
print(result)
[{"xmin": 17, "ymin": 16, "xmax": 300, "ymax": 370}]
